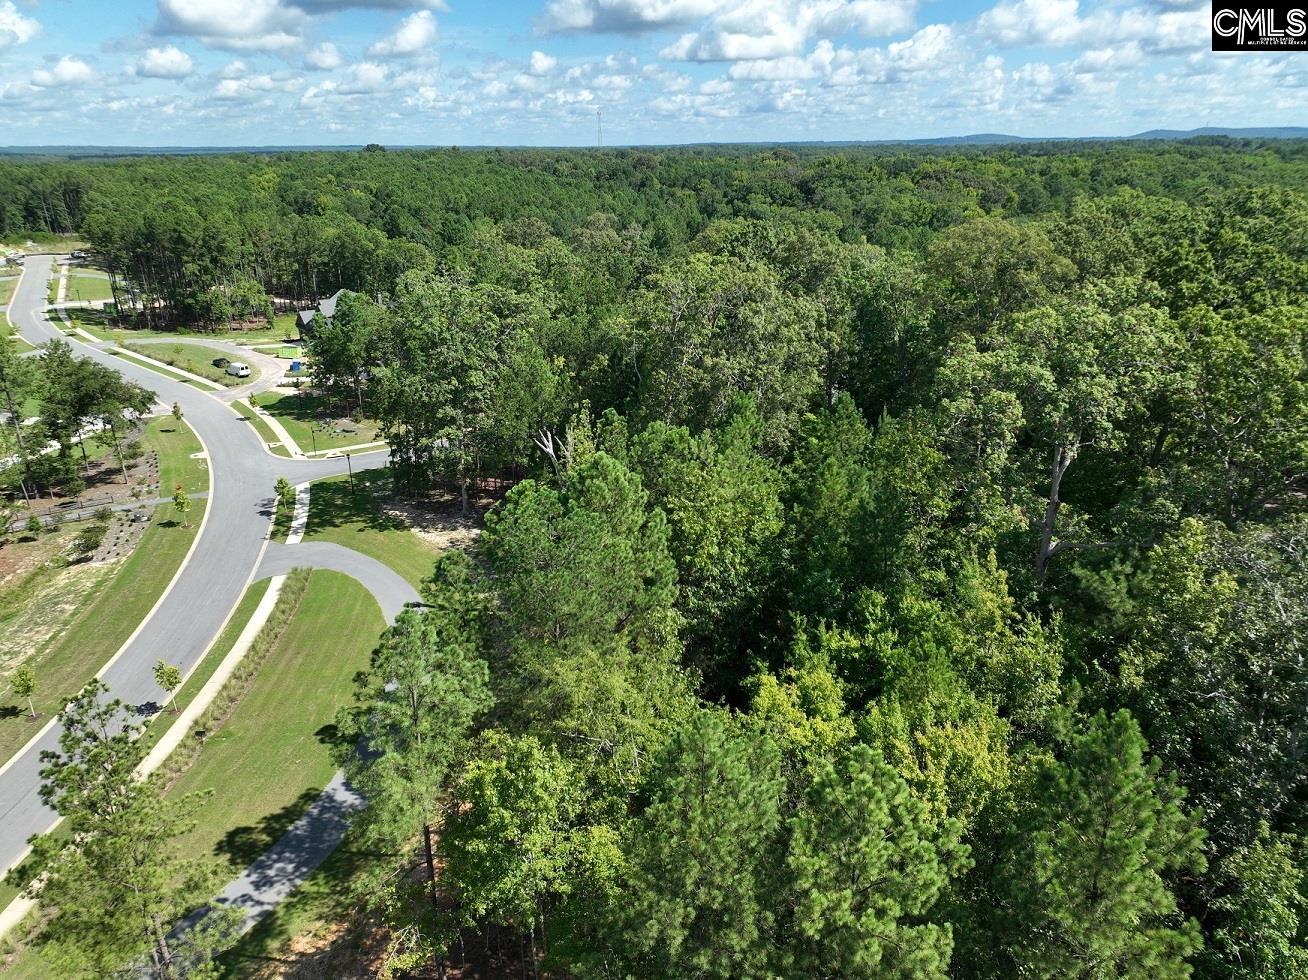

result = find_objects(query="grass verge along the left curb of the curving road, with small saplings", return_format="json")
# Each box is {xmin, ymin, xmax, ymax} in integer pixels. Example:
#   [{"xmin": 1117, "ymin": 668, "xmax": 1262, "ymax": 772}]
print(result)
[{"xmin": 0, "ymin": 419, "xmax": 208, "ymax": 763}]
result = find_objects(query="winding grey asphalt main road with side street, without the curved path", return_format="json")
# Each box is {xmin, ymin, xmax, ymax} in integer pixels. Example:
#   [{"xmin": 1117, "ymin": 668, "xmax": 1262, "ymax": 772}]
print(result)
[{"xmin": 0, "ymin": 255, "xmax": 387, "ymax": 871}]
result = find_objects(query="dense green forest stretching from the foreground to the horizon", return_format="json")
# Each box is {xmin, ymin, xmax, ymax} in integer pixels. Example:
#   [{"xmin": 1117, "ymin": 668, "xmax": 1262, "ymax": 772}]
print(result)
[{"xmin": 0, "ymin": 140, "xmax": 1308, "ymax": 980}]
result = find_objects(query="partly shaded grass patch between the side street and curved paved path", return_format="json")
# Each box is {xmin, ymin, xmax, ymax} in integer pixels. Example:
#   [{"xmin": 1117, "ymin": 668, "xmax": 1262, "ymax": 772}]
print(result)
[{"xmin": 305, "ymin": 470, "xmax": 441, "ymax": 587}]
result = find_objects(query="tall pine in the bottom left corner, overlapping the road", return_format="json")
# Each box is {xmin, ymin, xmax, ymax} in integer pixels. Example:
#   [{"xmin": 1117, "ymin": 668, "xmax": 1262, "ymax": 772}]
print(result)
[{"xmin": 26, "ymin": 682, "xmax": 228, "ymax": 977}]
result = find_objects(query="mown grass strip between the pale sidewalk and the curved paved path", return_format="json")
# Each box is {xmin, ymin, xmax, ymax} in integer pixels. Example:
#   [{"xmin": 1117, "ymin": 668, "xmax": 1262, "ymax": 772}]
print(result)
[{"xmin": 170, "ymin": 570, "xmax": 385, "ymax": 874}]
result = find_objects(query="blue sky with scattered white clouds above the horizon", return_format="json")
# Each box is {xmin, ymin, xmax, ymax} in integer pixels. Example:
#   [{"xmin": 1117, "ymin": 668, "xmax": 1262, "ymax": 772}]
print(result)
[{"xmin": 0, "ymin": 0, "xmax": 1308, "ymax": 145}]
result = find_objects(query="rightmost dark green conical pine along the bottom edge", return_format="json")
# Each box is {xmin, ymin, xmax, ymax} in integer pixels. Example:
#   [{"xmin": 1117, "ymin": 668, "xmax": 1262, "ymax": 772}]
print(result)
[{"xmin": 1001, "ymin": 710, "xmax": 1205, "ymax": 980}]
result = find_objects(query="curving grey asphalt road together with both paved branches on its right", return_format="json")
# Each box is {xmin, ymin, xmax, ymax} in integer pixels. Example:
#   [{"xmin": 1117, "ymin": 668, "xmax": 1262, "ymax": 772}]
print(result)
[{"xmin": 0, "ymin": 255, "xmax": 397, "ymax": 909}]
